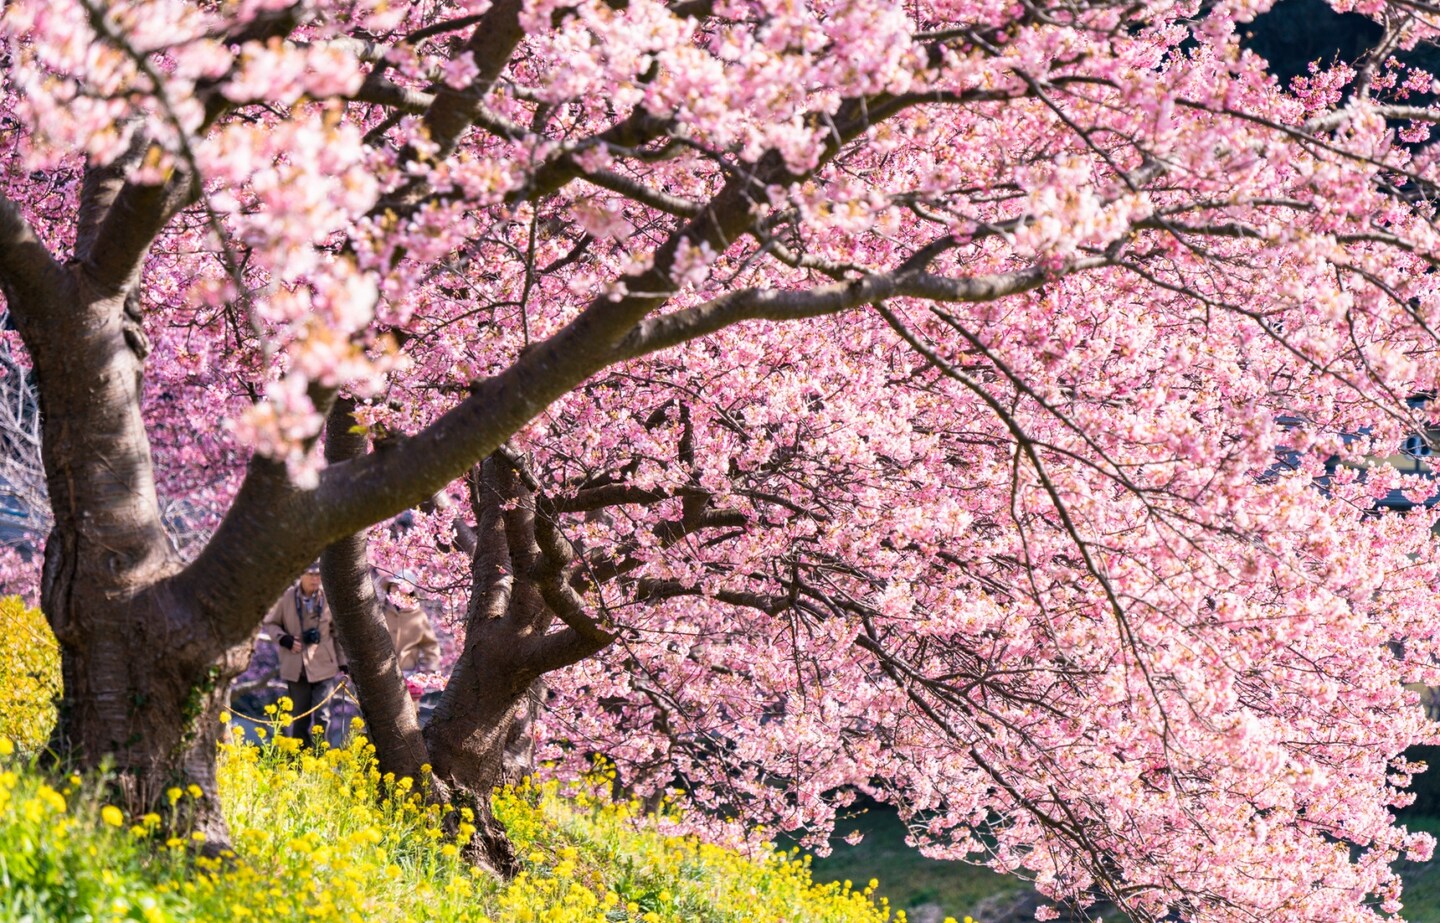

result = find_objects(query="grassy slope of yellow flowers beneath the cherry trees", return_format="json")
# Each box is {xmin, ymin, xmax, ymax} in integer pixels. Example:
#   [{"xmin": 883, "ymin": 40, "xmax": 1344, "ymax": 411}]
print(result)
[{"xmin": 0, "ymin": 708, "xmax": 903, "ymax": 923}]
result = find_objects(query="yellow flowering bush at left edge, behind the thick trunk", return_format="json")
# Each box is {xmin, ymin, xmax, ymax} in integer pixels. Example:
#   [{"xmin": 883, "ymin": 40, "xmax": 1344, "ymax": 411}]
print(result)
[{"xmin": 0, "ymin": 596, "xmax": 60, "ymax": 750}]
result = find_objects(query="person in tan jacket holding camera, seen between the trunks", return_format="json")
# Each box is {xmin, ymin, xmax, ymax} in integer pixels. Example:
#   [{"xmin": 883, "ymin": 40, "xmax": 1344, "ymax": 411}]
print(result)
[{"xmin": 262, "ymin": 563, "xmax": 348, "ymax": 744}]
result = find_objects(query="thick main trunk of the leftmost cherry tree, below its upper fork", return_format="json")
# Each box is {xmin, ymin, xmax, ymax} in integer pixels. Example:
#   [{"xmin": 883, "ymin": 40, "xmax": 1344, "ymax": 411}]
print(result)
[{"xmin": 23, "ymin": 269, "xmax": 248, "ymax": 848}]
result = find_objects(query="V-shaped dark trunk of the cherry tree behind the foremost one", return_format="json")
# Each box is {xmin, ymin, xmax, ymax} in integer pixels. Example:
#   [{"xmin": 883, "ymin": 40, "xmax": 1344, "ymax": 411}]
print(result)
[{"xmin": 321, "ymin": 414, "xmax": 609, "ymax": 877}]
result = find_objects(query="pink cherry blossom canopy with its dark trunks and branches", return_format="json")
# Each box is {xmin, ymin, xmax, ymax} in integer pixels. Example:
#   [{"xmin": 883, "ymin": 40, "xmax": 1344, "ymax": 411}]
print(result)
[{"xmin": 0, "ymin": 0, "xmax": 1440, "ymax": 922}]
